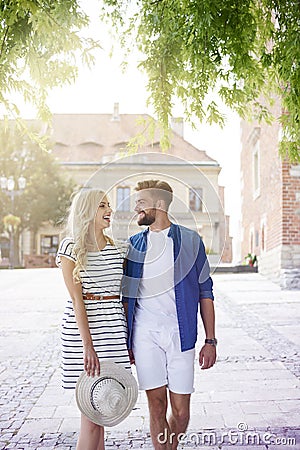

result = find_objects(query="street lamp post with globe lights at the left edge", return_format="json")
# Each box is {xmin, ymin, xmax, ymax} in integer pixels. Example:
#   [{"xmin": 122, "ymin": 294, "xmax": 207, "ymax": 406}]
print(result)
[{"xmin": 0, "ymin": 176, "xmax": 26, "ymax": 269}]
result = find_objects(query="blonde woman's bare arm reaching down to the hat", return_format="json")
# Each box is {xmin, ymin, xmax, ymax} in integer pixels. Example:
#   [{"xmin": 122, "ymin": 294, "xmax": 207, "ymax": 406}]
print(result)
[{"xmin": 61, "ymin": 256, "xmax": 100, "ymax": 376}]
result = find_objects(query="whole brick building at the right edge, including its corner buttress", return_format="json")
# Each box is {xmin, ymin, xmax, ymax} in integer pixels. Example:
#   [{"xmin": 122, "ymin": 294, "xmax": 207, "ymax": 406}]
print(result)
[{"xmin": 241, "ymin": 105, "xmax": 300, "ymax": 289}]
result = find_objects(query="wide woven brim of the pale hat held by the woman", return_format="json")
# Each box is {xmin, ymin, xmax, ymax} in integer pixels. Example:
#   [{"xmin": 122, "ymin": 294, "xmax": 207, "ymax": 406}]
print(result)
[{"xmin": 75, "ymin": 361, "xmax": 138, "ymax": 427}]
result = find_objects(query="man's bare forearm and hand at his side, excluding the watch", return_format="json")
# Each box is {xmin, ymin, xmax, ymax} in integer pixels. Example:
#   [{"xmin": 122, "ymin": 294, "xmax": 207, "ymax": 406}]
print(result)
[{"xmin": 199, "ymin": 298, "xmax": 217, "ymax": 369}]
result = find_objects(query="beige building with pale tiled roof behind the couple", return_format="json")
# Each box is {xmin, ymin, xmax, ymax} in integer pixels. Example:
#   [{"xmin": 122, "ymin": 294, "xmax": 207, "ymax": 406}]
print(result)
[{"xmin": 21, "ymin": 104, "xmax": 232, "ymax": 265}]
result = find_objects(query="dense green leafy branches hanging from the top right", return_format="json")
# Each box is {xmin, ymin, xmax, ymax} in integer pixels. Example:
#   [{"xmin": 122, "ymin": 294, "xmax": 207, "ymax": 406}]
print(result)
[{"xmin": 103, "ymin": 0, "xmax": 300, "ymax": 161}]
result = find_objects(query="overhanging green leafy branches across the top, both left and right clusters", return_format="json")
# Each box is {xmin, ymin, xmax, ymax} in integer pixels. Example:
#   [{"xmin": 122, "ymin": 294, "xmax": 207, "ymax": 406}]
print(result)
[{"xmin": 0, "ymin": 0, "xmax": 300, "ymax": 161}]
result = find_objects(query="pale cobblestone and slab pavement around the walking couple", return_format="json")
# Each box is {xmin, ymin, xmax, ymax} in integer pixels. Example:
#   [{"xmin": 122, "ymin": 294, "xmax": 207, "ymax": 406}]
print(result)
[{"xmin": 0, "ymin": 269, "xmax": 300, "ymax": 450}]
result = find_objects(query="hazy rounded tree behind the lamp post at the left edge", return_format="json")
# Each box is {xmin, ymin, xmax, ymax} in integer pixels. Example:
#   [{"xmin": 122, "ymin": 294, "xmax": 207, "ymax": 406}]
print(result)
[{"xmin": 0, "ymin": 123, "xmax": 74, "ymax": 246}]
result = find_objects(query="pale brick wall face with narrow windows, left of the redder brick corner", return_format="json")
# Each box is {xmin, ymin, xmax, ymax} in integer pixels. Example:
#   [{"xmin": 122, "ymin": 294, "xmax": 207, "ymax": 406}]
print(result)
[{"xmin": 241, "ymin": 99, "xmax": 282, "ymax": 258}]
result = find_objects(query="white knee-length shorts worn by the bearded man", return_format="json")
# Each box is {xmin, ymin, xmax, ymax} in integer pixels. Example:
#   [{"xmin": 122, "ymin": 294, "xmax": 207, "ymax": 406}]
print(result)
[{"xmin": 132, "ymin": 326, "xmax": 195, "ymax": 394}]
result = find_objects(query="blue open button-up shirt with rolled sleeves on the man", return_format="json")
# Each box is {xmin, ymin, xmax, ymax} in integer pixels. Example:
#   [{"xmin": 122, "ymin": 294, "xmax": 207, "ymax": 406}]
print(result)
[{"xmin": 122, "ymin": 223, "xmax": 214, "ymax": 351}]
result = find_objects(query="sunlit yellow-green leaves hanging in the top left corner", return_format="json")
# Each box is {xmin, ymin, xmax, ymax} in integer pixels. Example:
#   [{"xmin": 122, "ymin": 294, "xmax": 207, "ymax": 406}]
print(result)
[{"xmin": 0, "ymin": 0, "xmax": 98, "ymax": 132}]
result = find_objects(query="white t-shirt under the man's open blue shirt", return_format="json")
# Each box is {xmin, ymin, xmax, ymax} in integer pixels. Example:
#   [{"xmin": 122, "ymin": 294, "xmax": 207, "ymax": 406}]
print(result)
[{"xmin": 135, "ymin": 228, "xmax": 178, "ymax": 329}]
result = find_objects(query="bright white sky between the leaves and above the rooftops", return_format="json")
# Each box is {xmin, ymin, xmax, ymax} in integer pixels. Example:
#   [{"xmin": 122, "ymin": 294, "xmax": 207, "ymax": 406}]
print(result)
[{"xmin": 12, "ymin": 0, "xmax": 244, "ymax": 259}]
